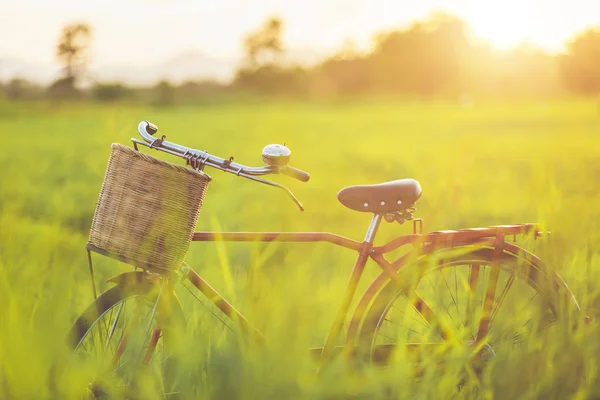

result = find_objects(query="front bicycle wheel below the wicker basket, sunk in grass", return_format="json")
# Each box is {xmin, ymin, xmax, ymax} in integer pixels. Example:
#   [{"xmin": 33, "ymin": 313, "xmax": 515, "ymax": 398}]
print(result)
[{"xmin": 69, "ymin": 273, "xmax": 184, "ymax": 398}]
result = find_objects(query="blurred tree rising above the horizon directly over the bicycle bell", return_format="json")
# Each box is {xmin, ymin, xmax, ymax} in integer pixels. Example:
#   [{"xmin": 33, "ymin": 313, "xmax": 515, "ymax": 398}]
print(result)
[{"xmin": 244, "ymin": 17, "xmax": 283, "ymax": 68}]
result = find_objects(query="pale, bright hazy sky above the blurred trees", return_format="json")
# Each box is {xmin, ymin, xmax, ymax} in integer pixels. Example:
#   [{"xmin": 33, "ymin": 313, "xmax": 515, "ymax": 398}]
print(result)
[{"xmin": 0, "ymin": 0, "xmax": 600, "ymax": 82}]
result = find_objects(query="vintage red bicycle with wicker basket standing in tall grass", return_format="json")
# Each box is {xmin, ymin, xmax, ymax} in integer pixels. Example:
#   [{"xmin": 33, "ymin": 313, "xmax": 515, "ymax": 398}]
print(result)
[{"xmin": 69, "ymin": 121, "xmax": 579, "ymax": 396}]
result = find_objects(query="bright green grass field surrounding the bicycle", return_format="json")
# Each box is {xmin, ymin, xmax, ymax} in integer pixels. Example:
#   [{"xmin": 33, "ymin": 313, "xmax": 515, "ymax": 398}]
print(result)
[{"xmin": 0, "ymin": 100, "xmax": 600, "ymax": 399}]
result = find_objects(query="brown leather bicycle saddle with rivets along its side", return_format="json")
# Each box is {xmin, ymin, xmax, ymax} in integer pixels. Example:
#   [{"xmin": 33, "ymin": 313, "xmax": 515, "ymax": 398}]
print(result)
[{"xmin": 338, "ymin": 179, "xmax": 421, "ymax": 214}]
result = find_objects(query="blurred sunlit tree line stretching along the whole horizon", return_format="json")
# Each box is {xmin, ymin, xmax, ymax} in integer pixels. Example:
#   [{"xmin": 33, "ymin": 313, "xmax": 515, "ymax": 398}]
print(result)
[{"xmin": 2, "ymin": 13, "xmax": 600, "ymax": 105}]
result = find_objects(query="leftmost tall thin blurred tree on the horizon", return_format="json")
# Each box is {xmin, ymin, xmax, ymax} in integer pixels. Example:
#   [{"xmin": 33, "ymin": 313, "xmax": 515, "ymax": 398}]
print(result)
[{"xmin": 56, "ymin": 23, "xmax": 91, "ymax": 85}]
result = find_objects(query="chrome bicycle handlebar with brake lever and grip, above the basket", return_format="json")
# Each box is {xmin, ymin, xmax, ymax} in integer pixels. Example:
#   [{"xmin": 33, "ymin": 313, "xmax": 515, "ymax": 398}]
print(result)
[{"xmin": 131, "ymin": 121, "xmax": 310, "ymax": 211}]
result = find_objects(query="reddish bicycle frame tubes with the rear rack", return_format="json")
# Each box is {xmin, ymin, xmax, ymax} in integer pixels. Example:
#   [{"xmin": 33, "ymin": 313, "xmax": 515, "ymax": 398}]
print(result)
[{"xmin": 175, "ymin": 219, "xmax": 541, "ymax": 367}]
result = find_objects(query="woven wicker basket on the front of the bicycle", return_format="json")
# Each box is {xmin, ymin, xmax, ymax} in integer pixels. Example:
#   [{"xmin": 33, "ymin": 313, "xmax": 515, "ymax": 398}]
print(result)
[{"xmin": 87, "ymin": 143, "xmax": 210, "ymax": 271}]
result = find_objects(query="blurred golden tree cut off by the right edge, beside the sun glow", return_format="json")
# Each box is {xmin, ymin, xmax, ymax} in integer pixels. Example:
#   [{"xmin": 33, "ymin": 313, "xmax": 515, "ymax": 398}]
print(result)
[{"xmin": 560, "ymin": 29, "xmax": 600, "ymax": 94}]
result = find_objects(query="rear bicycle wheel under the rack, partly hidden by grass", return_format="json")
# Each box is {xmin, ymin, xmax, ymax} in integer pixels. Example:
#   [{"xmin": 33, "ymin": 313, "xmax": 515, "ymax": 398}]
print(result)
[{"xmin": 358, "ymin": 246, "xmax": 578, "ymax": 372}]
